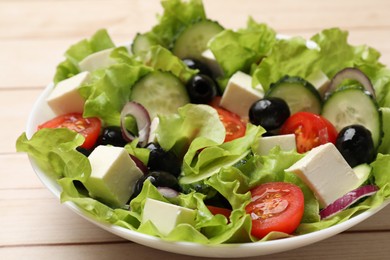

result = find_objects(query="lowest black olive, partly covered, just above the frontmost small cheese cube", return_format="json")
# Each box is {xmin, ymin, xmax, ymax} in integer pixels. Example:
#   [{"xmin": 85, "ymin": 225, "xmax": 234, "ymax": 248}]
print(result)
[{"xmin": 132, "ymin": 171, "xmax": 181, "ymax": 198}]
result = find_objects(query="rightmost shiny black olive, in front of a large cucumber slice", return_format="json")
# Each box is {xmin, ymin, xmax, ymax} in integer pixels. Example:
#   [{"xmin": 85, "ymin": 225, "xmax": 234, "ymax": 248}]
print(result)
[{"xmin": 336, "ymin": 125, "xmax": 375, "ymax": 167}]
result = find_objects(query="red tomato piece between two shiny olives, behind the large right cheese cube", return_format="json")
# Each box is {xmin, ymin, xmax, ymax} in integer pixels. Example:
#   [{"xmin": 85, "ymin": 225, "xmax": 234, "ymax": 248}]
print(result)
[{"xmin": 280, "ymin": 112, "xmax": 337, "ymax": 153}]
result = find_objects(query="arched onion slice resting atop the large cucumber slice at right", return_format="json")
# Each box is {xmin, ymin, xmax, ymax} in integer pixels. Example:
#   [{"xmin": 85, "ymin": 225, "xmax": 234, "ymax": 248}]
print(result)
[{"xmin": 325, "ymin": 68, "xmax": 375, "ymax": 98}]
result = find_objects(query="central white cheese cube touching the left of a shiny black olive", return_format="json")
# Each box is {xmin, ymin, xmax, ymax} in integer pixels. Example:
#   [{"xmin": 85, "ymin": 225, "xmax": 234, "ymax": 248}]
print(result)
[{"xmin": 220, "ymin": 71, "xmax": 264, "ymax": 119}]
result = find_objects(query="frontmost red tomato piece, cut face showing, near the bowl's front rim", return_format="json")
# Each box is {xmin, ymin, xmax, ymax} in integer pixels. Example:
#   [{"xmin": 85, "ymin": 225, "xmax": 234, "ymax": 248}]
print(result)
[{"xmin": 245, "ymin": 182, "xmax": 304, "ymax": 239}]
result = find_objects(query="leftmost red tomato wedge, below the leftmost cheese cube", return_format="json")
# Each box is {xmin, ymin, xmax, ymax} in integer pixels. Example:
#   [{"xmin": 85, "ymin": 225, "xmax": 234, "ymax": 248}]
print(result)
[{"xmin": 38, "ymin": 113, "xmax": 101, "ymax": 149}]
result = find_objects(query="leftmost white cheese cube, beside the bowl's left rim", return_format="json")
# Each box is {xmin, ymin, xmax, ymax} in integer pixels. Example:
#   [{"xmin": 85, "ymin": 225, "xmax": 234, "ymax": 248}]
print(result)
[{"xmin": 46, "ymin": 71, "xmax": 90, "ymax": 115}]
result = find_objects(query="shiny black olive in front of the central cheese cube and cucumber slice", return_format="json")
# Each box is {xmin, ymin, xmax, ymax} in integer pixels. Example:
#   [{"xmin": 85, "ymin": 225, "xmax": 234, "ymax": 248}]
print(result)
[{"xmin": 249, "ymin": 97, "xmax": 290, "ymax": 131}]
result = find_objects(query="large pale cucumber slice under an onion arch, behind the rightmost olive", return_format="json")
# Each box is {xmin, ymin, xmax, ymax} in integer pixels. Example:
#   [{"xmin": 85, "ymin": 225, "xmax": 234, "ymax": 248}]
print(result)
[{"xmin": 322, "ymin": 88, "xmax": 382, "ymax": 148}]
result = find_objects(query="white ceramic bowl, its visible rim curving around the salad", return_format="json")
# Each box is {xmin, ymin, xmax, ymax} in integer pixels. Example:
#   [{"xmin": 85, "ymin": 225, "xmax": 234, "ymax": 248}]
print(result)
[{"xmin": 26, "ymin": 84, "xmax": 388, "ymax": 258}]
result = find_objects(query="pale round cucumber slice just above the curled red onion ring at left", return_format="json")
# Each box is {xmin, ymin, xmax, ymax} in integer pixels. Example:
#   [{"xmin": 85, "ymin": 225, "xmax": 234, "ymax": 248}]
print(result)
[{"xmin": 130, "ymin": 71, "xmax": 190, "ymax": 119}]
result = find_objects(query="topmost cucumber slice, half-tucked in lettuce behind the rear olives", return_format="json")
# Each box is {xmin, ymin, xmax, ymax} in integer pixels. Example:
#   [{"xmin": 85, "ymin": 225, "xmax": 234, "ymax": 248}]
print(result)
[{"xmin": 172, "ymin": 20, "xmax": 224, "ymax": 60}]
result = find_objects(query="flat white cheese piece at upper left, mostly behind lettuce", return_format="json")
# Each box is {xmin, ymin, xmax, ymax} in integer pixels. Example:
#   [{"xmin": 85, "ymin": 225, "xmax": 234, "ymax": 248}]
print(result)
[{"xmin": 79, "ymin": 49, "xmax": 117, "ymax": 72}]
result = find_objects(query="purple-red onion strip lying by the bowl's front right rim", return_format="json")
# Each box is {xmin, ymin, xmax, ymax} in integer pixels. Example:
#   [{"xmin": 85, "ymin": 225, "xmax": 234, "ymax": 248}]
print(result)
[{"xmin": 320, "ymin": 185, "xmax": 379, "ymax": 219}]
